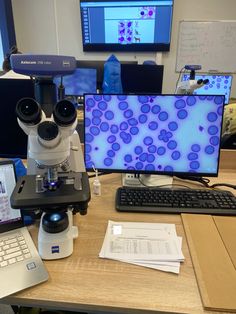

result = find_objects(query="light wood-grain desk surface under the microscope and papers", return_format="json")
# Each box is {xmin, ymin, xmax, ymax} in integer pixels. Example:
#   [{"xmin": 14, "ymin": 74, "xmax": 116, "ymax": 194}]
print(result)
[{"xmin": 1, "ymin": 169, "xmax": 235, "ymax": 314}]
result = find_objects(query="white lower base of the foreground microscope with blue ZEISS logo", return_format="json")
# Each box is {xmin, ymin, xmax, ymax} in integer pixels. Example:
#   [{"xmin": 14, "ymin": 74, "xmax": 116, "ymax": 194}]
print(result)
[{"xmin": 38, "ymin": 211, "xmax": 78, "ymax": 260}]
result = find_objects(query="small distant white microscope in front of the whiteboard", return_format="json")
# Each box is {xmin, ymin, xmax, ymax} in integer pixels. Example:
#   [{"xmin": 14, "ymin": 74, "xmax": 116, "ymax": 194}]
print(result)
[{"xmin": 175, "ymin": 65, "xmax": 209, "ymax": 95}]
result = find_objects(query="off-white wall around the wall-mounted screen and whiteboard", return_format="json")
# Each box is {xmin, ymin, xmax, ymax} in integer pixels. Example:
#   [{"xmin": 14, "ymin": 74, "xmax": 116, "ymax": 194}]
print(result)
[{"xmin": 12, "ymin": 0, "xmax": 236, "ymax": 97}]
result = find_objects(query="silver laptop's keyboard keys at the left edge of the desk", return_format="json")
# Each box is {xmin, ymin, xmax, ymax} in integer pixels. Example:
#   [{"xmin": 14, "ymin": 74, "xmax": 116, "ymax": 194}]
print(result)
[{"xmin": 0, "ymin": 233, "xmax": 31, "ymax": 268}]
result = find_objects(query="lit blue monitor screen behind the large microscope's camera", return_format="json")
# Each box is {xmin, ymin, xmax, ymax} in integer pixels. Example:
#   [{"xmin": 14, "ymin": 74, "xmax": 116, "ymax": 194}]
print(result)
[{"xmin": 53, "ymin": 68, "xmax": 97, "ymax": 96}]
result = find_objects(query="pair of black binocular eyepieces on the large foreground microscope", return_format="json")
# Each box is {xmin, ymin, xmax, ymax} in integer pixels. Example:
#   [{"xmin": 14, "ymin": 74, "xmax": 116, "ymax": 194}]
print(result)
[{"xmin": 16, "ymin": 98, "xmax": 77, "ymax": 127}]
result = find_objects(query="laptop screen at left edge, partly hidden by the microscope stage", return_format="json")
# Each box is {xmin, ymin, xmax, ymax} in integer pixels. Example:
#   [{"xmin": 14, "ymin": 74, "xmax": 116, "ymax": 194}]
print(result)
[{"xmin": 0, "ymin": 161, "xmax": 21, "ymax": 226}]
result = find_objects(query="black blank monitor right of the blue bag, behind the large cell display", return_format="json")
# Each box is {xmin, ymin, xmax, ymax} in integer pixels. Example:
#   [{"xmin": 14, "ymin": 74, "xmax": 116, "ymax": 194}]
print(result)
[{"xmin": 121, "ymin": 64, "xmax": 164, "ymax": 94}]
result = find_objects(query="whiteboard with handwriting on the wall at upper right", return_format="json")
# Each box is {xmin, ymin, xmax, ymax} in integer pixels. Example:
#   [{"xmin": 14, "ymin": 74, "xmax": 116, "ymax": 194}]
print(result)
[{"xmin": 176, "ymin": 21, "xmax": 236, "ymax": 73}]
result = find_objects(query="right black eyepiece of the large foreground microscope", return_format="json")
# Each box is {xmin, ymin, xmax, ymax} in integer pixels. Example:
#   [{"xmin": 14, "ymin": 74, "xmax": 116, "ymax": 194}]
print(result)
[{"xmin": 53, "ymin": 99, "xmax": 77, "ymax": 126}]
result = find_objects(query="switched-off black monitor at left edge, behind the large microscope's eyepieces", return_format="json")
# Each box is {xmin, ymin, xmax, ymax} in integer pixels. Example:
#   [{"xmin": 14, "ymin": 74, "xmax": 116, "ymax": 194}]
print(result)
[{"xmin": 0, "ymin": 78, "xmax": 34, "ymax": 158}]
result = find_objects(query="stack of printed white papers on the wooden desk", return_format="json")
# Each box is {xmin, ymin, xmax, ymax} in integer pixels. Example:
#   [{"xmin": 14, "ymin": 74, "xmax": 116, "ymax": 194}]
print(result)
[{"xmin": 99, "ymin": 221, "xmax": 184, "ymax": 274}]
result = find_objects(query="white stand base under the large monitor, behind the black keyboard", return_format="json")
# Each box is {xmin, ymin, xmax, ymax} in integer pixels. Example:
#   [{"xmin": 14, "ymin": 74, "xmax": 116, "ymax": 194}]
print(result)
[{"xmin": 122, "ymin": 173, "xmax": 173, "ymax": 187}]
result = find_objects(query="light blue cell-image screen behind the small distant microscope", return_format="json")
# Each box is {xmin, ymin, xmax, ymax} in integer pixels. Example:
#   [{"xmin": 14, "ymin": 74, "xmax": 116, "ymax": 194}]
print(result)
[{"xmin": 182, "ymin": 74, "xmax": 233, "ymax": 104}]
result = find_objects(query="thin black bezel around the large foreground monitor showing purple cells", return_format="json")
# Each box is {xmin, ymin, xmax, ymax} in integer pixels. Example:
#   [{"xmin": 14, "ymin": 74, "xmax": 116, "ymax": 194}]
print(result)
[{"xmin": 83, "ymin": 93, "xmax": 225, "ymax": 179}]
